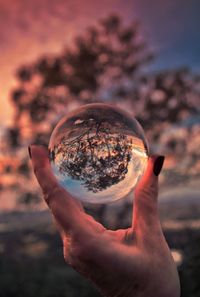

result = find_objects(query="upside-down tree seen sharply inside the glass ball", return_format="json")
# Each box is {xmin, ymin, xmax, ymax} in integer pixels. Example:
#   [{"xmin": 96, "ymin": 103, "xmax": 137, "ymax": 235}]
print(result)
[{"xmin": 50, "ymin": 119, "xmax": 133, "ymax": 193}]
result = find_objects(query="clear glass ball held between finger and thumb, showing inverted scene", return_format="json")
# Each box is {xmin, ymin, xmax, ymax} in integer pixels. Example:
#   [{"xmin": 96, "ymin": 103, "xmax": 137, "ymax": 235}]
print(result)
[{"xmin": 49, "ymin": 103, "xmax": 148, "ymax": 203}]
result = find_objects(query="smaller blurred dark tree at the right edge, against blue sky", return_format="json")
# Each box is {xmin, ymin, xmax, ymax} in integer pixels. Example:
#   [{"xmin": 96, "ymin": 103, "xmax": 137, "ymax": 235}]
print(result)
[{"xmin": 138, "ymin": 68, "xmax": 200, "ymax": 126}]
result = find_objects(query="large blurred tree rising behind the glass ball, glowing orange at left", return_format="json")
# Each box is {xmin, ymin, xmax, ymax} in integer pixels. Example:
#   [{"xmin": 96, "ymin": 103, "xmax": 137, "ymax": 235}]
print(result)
[{"xmin": 9, "ymin": 15, "xmax": 152, "ymax": 149}]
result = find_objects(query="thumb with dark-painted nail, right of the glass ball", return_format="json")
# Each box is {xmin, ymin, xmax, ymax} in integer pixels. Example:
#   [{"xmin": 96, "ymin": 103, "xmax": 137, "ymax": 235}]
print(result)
[{"xmin": 133, "ymin": 156, "xmax": 164, "ymax": 232}]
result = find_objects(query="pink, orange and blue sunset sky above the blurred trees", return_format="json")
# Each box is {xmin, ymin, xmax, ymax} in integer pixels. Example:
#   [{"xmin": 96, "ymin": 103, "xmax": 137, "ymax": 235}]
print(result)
[{"xmin": 0, "ymin": 0, "xmax": 200, "ymax": 126}]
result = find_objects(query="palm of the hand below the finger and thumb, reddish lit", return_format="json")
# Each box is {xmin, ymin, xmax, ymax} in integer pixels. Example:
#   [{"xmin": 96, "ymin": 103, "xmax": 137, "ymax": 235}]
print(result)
[{"xmin": 63, "ymin": 206, "xmax": 179, "ymax": 297}]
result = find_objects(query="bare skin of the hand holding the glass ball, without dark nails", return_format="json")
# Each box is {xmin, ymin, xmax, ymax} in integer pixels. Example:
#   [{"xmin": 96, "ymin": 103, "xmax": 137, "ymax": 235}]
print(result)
[{"xmin": 31, "ymin": 146, "xmax": 180, "ymax": 297}]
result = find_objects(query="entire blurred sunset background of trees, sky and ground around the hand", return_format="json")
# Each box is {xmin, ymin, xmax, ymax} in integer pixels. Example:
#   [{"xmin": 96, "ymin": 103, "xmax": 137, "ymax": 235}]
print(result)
[{"xmin": 0, "ymin": 0, "xmax": 200, "ymax": 297}]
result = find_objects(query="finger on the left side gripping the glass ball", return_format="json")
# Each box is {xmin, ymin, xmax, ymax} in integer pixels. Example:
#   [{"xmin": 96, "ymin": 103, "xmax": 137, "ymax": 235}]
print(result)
[{"xmin": 30, "ymin": 145, "xmax": 90, "ymax": 232}]
